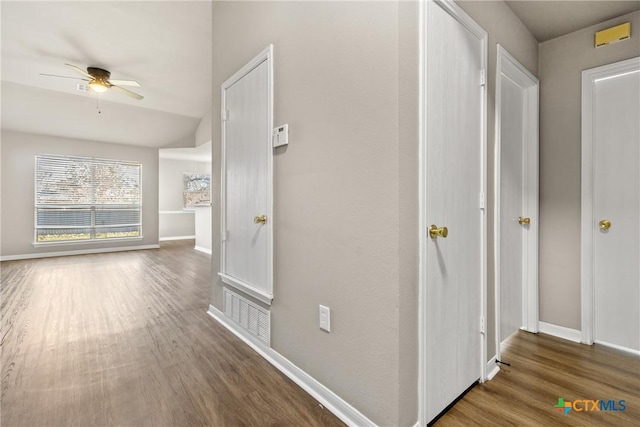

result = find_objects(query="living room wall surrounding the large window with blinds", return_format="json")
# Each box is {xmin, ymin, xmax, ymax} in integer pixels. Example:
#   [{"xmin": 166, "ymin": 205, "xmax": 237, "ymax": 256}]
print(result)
[{"xmin": 0, "ymin": 131, "xmax": 158, "ymax": 257}]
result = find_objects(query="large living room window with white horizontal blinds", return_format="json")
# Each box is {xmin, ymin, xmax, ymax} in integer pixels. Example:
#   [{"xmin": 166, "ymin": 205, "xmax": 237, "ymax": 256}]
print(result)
[{"xmin": 35, "ymin": 155, "xmax": 142, "ymax": 243}]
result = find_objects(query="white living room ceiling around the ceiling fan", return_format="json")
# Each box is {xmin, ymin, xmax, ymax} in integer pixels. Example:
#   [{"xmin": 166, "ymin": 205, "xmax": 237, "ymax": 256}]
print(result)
[{"xmin": 1, "ymin": 1, "xmax": 212, "ymax": 147}]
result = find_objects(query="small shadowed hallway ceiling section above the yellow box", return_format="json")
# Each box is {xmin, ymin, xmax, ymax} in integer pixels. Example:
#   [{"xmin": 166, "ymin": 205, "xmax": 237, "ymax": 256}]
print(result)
[{"xmin": 506, "ymin": 0, "xmax": 640, "ymax": 42}]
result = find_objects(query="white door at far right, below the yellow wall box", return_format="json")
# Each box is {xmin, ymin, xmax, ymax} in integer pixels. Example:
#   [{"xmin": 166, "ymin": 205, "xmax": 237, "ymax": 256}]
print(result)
[{"xmin": 583, "ymin": 58, "xmax": 640, "ymax": 353}]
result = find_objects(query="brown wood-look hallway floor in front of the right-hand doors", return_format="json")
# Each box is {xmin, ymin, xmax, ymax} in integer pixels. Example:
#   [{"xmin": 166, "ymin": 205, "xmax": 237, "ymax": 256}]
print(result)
[{"xmin": 434, "ymin": 332, "xmax": 640, "ymax": 427}]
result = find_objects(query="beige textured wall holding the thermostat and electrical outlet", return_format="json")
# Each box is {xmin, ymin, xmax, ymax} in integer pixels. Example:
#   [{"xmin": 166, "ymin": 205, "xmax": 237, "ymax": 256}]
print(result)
[{"xmin": 212, "ymin": 2, "xmax": 417, "ymax": 425}]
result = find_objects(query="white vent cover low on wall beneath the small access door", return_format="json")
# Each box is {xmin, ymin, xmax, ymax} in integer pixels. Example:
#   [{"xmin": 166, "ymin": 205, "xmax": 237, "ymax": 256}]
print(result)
[{"xmin": 223, "ymin": 288, "xmax": 271, "ymax": 345}]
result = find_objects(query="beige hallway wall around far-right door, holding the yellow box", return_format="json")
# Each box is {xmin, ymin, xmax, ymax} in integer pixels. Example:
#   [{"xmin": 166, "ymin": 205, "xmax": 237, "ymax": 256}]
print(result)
[{"xmin": 539, "ymin": 12, "xmax": 640, "ymax": 330}]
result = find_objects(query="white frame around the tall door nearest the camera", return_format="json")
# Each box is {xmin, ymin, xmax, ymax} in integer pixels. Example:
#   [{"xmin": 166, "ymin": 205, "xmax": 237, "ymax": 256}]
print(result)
[{"xmin": 418, "ymin": 0, "xmax": 488, "ymax": 426}]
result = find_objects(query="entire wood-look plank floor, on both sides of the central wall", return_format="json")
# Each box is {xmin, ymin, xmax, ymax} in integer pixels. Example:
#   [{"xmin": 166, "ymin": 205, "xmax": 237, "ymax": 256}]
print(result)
[{"xmin": 0, "ymin": 241, "xmax": 640, "ymax": 427}]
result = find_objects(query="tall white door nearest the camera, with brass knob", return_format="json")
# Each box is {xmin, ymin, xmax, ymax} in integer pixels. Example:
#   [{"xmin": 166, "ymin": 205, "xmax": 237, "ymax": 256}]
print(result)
[{"xmin": 421, "ymin": 2, "xmax": 486, "ymax": 423}]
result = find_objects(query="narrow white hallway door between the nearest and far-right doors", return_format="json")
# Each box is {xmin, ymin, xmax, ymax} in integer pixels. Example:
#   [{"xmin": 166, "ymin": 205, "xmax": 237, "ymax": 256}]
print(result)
[{"xmin": 495, "ymin": 45, "xmax": 538, "ymax": 360}]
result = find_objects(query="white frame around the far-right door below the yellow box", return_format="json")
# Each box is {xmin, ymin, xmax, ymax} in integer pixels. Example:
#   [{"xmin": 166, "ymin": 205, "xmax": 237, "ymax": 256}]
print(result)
[{"xmin": 580, "ymin": 57, "xmax": 640, "ymax": 344}]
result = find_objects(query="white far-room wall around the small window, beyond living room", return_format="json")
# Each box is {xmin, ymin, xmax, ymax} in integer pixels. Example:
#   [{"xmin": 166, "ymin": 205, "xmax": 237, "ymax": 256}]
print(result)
[{"xmin": 158, "ymin": 158, "xmax": 211, "ymax": 240}]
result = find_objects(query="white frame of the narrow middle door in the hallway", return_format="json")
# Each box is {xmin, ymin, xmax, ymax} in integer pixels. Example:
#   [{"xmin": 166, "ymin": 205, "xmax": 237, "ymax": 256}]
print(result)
[{"xmin": 487, "ymin": 44, "xmax": 540, "ymax": 363}]
